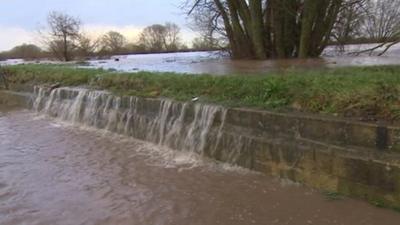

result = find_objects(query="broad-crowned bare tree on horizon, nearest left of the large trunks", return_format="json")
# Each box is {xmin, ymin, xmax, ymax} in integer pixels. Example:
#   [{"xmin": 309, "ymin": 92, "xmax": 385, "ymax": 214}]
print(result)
[{"xmin": 139, "ymin": 23, "xmax": 181, "ymax": 51}]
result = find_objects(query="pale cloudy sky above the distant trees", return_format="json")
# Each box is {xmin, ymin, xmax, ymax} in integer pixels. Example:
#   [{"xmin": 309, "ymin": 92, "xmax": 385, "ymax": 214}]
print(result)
[{"xmin": 0, "ymin": 0, "xmax": 194, "ymax": 51}]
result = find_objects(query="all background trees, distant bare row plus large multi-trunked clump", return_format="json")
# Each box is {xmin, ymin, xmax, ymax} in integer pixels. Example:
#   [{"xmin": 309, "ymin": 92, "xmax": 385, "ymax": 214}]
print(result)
[{"xmin": 4, "ymin": 0, "xmax": 400, "ymax": 61}]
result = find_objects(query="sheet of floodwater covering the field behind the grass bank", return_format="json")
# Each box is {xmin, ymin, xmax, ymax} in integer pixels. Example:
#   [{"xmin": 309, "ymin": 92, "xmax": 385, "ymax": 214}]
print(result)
[{"xmin": 0, "ymin": 44, "xmax": 400, "ymax": 75}]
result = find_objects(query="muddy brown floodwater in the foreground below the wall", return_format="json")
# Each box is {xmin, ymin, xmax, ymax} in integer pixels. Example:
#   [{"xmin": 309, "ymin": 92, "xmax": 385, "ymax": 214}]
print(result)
[{"xmin": 0, "ymin": 108, "xmax": 400, "ymax": 225}]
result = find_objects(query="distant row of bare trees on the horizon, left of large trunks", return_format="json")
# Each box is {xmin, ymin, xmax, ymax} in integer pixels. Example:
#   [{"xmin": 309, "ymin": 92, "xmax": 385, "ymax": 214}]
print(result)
[{"xmin": 0, "ymin": 12, "xmax": 220, "ymax": 61}]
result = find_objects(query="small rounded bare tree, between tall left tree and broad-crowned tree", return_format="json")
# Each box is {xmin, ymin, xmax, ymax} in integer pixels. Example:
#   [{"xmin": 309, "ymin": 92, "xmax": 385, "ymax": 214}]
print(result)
[{"xmin": 101, "ymin": 31, "xmax": 127, "ymax": 54}]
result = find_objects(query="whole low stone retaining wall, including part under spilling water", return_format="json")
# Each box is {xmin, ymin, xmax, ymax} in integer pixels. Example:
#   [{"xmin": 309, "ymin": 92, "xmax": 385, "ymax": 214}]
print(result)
[{"xmin": 0, "ymin": 88, "xmax": 400, "ymax": 208}]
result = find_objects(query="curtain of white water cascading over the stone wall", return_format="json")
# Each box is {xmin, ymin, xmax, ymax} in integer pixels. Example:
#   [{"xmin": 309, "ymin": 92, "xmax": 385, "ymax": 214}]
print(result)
[{"xmin": 33, "ymin": 87, "xmax": 226, "ymax": 156}]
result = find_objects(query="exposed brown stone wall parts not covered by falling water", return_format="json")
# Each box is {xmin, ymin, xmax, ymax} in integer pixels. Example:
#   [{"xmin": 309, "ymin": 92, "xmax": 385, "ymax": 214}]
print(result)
[{"xmin": 0, "ymin": 88, "xmax": 400, "ymax": 208}]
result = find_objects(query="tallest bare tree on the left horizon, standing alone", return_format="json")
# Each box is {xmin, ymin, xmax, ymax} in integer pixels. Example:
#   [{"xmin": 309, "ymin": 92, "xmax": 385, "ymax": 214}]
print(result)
[{"xmin": 43, "ymin": 11, "xmax": 81, "ymax": 61}]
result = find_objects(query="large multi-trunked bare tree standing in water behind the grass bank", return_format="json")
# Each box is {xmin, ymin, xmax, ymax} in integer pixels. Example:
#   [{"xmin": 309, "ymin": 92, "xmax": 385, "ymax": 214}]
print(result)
[{"xmin": 186, "ymin": 0, "xmax": 349, "ymax": 59}]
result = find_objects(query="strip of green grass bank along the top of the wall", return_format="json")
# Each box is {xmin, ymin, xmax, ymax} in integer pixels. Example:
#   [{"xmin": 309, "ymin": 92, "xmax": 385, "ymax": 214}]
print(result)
[{"xmin": 2, "ymin": 65, "xmax": 400, "ymax": 122}]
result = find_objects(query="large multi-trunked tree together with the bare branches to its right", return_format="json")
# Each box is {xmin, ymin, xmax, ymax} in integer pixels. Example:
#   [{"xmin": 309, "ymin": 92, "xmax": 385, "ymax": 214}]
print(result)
[{"xmin": 184, "ymin": 0, "xmax": 400, "ymax": 59}]
